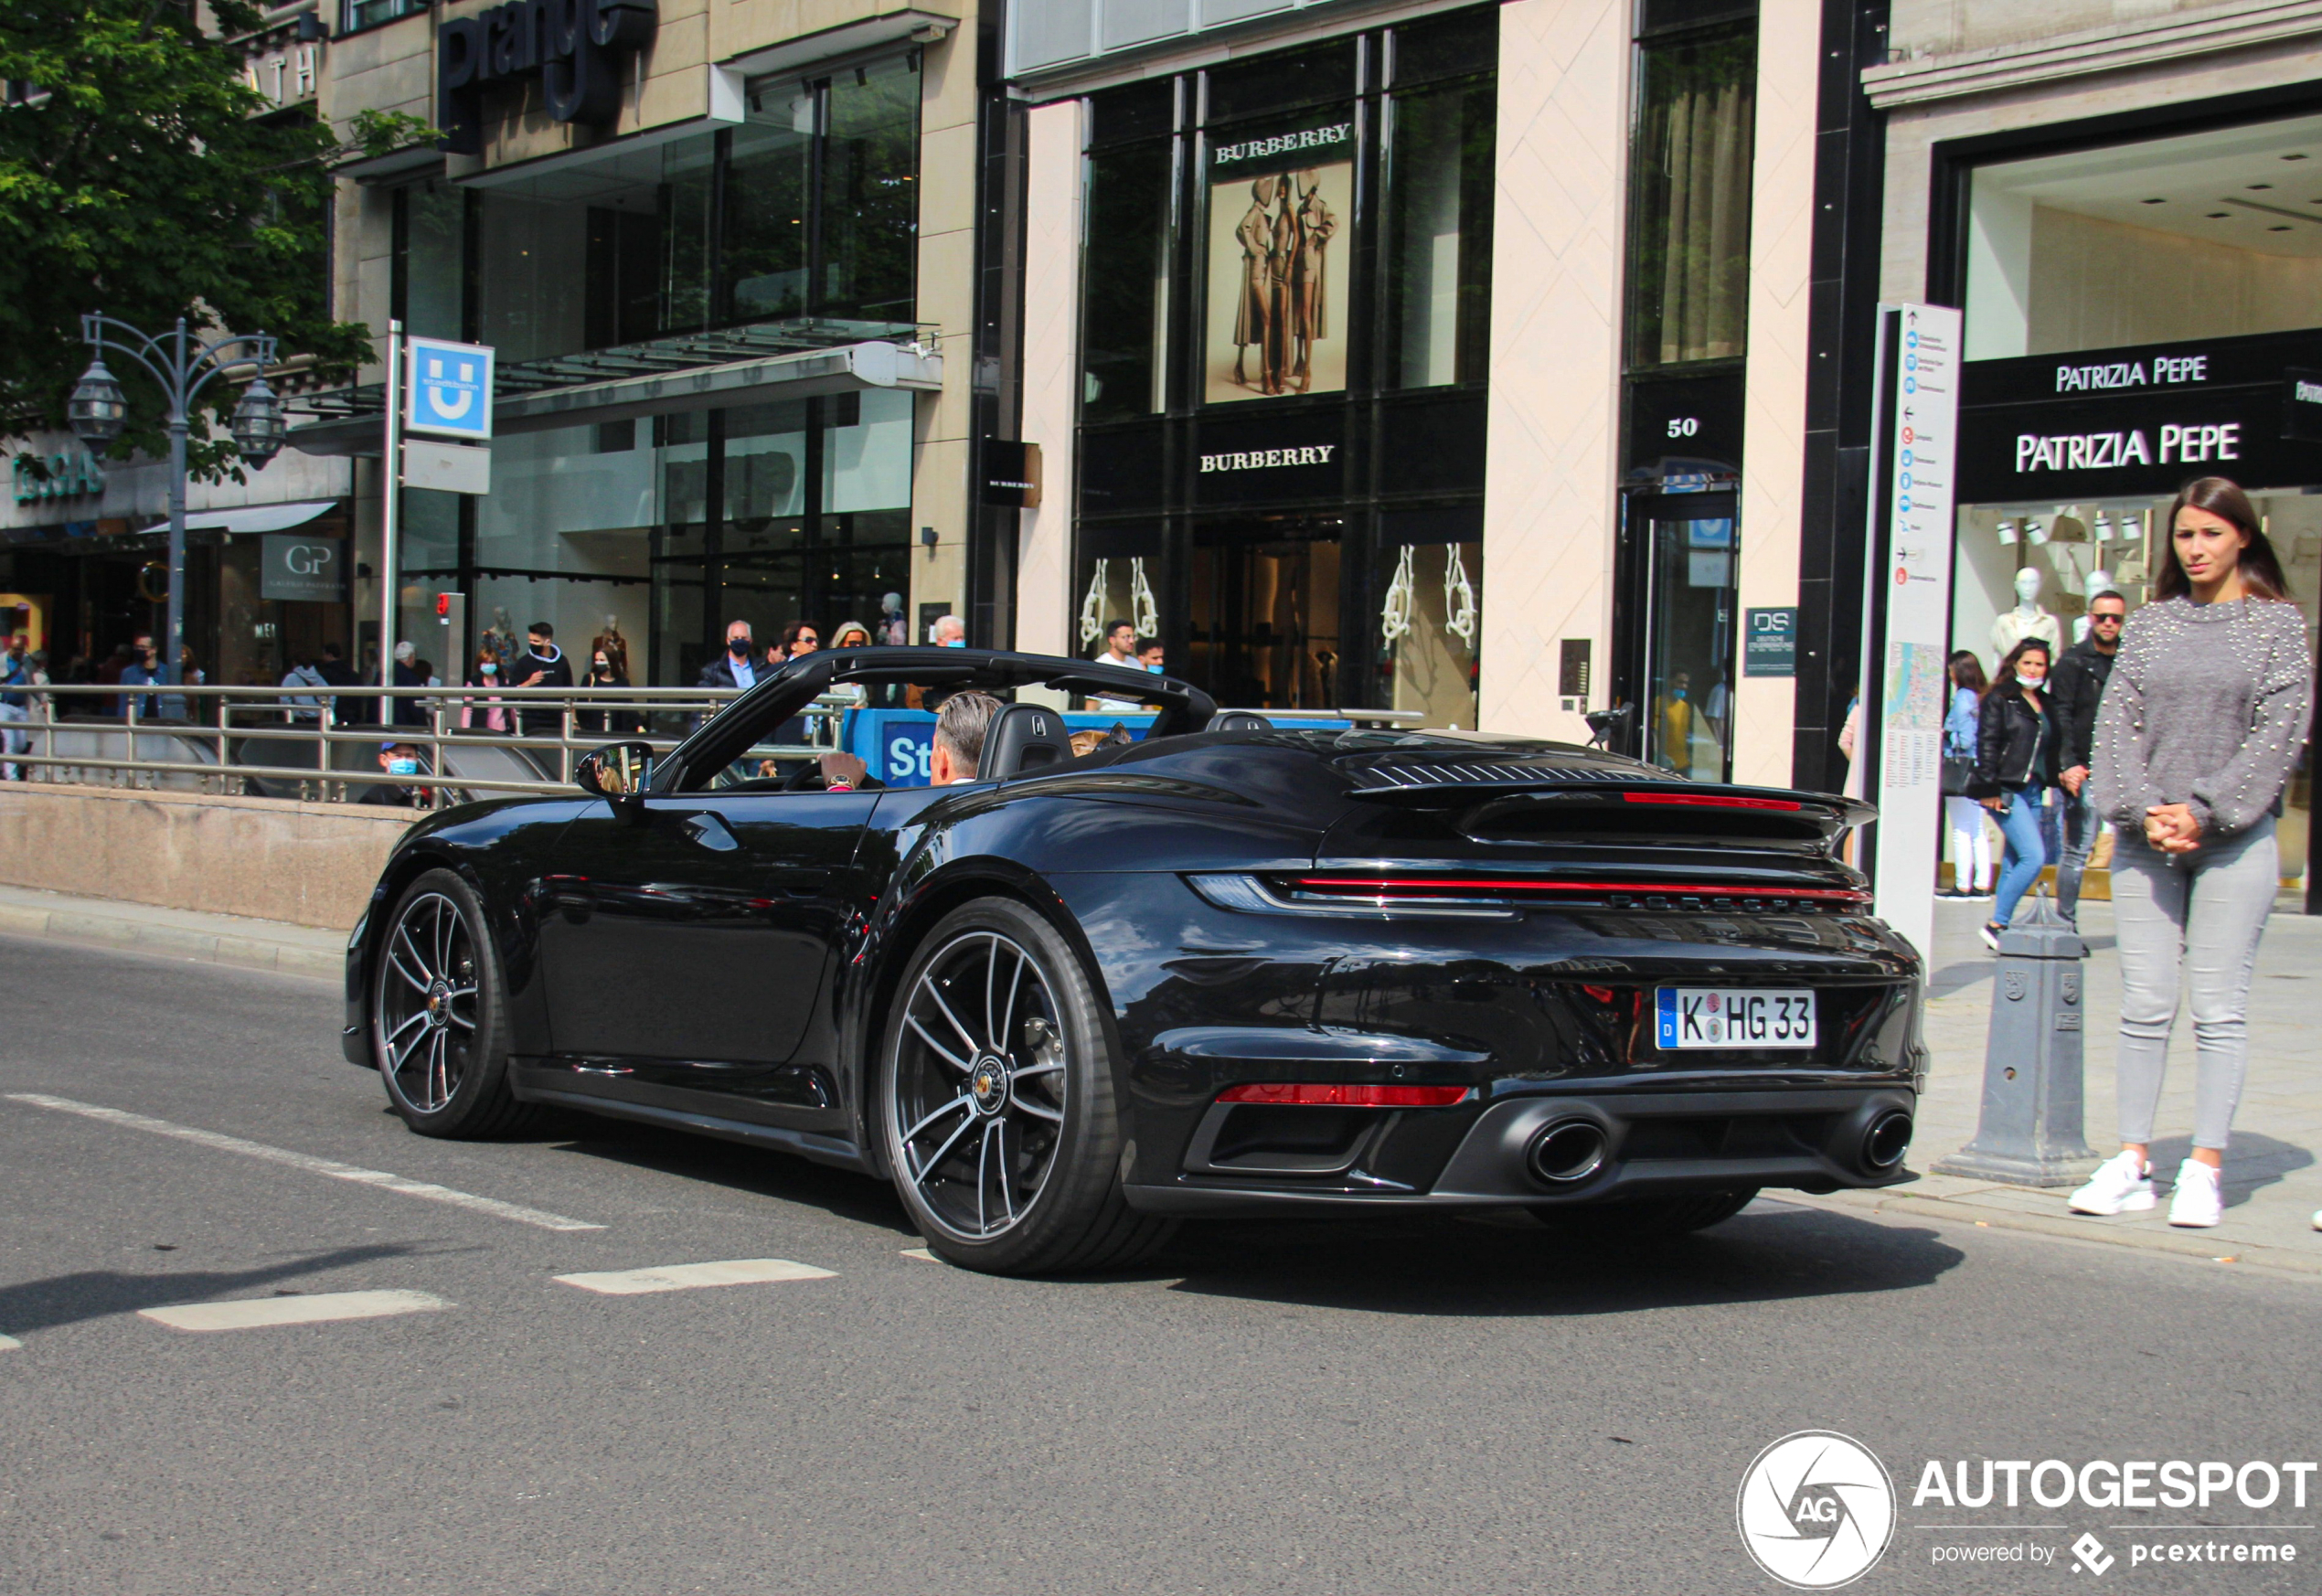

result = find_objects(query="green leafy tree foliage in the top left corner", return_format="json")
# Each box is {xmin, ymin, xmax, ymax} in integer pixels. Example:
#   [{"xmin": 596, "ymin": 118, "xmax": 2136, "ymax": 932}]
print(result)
[{"xmin": 0, "ymin": 0, "xmax": 434, "ymax": 473}]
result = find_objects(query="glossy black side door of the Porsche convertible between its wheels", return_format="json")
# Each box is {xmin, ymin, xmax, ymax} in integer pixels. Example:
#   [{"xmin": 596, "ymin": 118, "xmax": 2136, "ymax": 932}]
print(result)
[{"xmin": 538, "ymin": 793, "xmax": 878, "ymax": 1117}]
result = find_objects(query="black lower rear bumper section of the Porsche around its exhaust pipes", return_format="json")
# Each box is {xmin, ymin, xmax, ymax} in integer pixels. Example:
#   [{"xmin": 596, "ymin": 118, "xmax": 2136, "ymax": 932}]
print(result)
[{"xmin": 1124, "ymin": 1085, "xmax": 1918, "ymax": 1215}]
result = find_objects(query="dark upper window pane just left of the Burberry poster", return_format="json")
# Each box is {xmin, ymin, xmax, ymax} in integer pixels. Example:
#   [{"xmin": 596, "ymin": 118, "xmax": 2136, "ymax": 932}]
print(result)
[{"xmin": 1080, "ymin": 142, "xmax": 1175, "ymax": 420}]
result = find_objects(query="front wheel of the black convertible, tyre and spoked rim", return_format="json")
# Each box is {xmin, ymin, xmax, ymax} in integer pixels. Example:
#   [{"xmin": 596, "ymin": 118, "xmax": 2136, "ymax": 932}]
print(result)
[{"xmin": 369, "ymin": 869, "xmax": 532, "ymax": 1141}]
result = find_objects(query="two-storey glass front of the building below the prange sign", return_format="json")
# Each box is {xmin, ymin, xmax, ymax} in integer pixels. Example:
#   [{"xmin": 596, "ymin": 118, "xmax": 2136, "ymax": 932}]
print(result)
[{"xmin": 392, "ymin": 53, "xmax": 920, "ymax": 686}]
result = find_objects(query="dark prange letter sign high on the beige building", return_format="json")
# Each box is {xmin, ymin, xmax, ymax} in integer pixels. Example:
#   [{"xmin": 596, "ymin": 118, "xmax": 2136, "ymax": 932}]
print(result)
[{"xmin": 437, "ymin": 0, "xmax": 659, "ymax": 155}]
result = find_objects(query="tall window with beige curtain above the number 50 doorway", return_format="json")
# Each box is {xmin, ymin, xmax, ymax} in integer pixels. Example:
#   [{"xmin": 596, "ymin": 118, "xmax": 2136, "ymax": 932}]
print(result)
[{"xmin": 1628, "ymin": 33, "xmax": 1758, "ymax": 367}]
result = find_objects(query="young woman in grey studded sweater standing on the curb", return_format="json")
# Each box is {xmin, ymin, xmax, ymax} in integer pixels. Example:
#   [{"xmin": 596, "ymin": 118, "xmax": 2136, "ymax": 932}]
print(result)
[{"xmin": 2072, "ymin": 476, "xmax": 2313, "ymax": 1227}]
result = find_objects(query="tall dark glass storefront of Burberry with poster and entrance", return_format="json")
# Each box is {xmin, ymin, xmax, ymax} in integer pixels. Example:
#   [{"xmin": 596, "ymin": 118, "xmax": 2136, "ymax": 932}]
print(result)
[{"xmin": 1075, "ymin": 7, "xmax": 1497, "ymax": 727}]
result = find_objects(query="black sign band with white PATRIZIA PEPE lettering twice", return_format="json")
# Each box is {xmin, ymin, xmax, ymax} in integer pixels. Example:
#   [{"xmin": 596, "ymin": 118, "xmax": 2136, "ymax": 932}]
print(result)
[{"xmin": 1957, "ymin": 330, "xmax": 2322, "ymax": 505}]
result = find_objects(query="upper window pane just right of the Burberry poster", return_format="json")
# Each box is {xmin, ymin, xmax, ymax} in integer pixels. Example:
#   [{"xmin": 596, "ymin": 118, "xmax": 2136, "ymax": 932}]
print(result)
[{"xmin": 1379, "ymin": 83, "xmax": 1496, "ymax": 388}]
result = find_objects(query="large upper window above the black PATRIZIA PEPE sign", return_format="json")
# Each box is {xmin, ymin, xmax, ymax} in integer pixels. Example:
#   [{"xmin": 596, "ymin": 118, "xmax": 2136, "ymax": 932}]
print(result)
[{"xmin": 1965, "ymin": 116, "xmax": 2322, "ymax": 360}]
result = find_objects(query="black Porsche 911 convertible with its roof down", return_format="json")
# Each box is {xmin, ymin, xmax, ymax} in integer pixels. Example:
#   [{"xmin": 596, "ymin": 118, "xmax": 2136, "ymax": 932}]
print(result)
[{"xmin": 344, "ymin": 648, "xmax": 1925, "ymax": 1273}]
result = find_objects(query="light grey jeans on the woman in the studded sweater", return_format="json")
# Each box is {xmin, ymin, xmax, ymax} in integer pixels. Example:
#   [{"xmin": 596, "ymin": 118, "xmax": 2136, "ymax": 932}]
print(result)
[{"xmin": 2113, "ymin": 815, "xmax": 2280, "ymax": 1153}]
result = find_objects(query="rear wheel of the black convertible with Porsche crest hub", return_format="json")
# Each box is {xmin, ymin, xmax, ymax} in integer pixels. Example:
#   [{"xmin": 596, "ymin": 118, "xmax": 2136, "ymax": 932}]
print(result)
[{"xmin": 876, "ymin": 897, "xmax": 1175, "ymax": 1275}]
